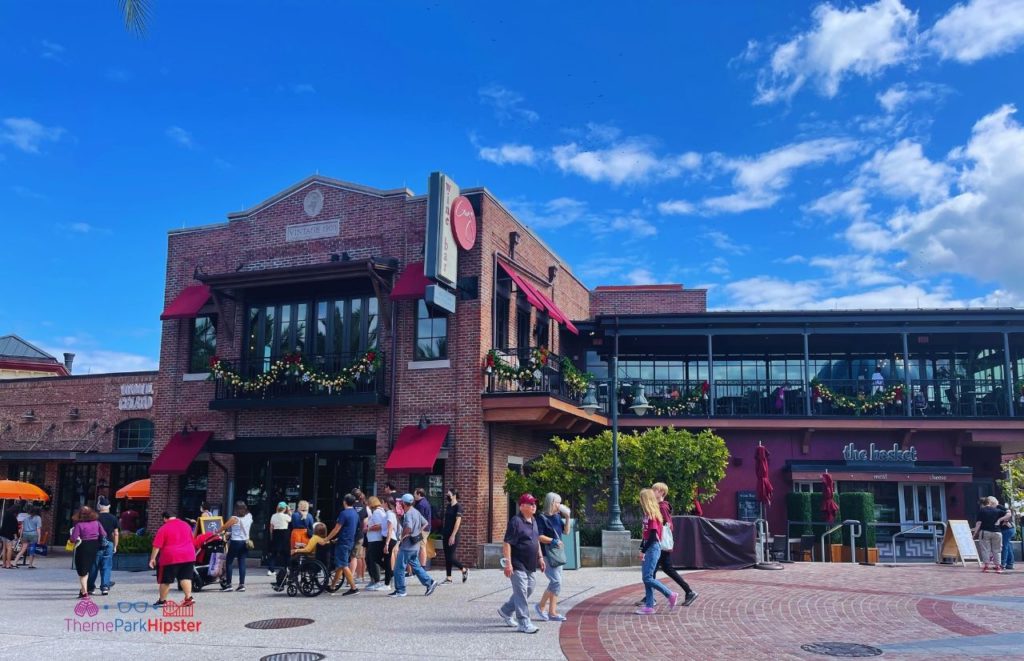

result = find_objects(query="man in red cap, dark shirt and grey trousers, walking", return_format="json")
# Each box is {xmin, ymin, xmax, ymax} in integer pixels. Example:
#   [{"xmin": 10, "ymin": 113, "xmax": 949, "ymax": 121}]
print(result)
[{"xmin": 498, "ymin": 493, "xmax": 545, "ymax": 633}]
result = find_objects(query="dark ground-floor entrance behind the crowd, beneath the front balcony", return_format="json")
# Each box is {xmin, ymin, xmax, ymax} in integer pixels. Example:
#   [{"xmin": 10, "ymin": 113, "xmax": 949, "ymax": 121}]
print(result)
[{"xmin": 234, "ymin": 452, "xmax": 376, "ymax": 552}]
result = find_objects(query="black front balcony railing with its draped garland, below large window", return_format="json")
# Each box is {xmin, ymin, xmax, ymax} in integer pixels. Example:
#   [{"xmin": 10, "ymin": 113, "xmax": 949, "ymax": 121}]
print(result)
[{"xmin": 210, "ymin": 350, "xmax": 387, "ymax": 408}]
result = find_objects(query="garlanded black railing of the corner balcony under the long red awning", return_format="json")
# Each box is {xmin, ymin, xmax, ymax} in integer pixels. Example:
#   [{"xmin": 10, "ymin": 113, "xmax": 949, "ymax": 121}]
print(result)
[{"xmin": 486, "ymin": 347, "xmax": 583, "ymax": 403}]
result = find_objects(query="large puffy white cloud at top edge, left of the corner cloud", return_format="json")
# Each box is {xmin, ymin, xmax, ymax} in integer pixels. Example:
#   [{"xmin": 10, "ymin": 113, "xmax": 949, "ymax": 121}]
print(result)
[{"xmin": 748, "ymin": 0, "xmax": 918, "ymax": 103}]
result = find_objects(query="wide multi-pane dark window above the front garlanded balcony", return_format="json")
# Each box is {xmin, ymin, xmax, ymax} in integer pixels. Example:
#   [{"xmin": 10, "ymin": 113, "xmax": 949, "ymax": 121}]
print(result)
[{"xmin": 246, "ymin": 296, "xmax": 380, "ymax": 369}]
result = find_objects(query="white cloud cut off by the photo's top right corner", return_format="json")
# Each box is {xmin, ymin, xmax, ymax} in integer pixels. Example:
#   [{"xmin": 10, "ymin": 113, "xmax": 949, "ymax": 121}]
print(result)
[{"xmin": 926, "ymin": 0, "xmax": 1024, "ymax": 63}]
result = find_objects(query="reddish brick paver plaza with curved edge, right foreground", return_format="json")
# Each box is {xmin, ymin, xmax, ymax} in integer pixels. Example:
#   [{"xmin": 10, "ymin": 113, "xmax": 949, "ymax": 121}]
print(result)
[{"xmin": 560, "ymin": 563, "xmax": 1024, "ymax": 661}]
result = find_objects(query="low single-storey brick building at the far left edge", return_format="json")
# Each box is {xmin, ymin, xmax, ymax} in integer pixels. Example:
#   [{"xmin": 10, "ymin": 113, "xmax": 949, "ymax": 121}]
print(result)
[{"xmin": 0, "ymin": 371, "xmax": 160, "ymax": 543}]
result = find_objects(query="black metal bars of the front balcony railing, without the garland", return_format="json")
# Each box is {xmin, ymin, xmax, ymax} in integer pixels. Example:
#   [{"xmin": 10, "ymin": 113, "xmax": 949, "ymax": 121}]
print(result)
[{"xmin": 214, "ymin": 350, "xmax": 387, "ymax": 400}]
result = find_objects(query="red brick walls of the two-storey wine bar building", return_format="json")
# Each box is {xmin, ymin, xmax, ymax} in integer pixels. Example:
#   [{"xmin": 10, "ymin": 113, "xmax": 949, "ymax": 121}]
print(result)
[{"xmin": 150, "ymin": 180, "xmax": 590, "ymax": 562}]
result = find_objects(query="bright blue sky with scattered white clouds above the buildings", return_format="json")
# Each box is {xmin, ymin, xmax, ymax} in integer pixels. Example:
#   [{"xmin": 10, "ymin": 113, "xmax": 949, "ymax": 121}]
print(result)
[{"xmin": 0, "ymin": 0, "xmax": 1024, "ymax": 372}]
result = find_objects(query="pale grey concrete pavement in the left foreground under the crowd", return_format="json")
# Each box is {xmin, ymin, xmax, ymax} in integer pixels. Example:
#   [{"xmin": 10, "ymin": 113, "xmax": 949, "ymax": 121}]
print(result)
[{"xmin": 0, "ymin": 555, "xmax": 642, "ymax": 661}]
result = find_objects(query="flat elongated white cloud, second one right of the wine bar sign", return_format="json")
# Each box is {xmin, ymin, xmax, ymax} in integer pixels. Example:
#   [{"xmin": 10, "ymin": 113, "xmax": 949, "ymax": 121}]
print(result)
[{"xmin": 551, "ymin": 138, "xmax": 701, "ymax": 185}]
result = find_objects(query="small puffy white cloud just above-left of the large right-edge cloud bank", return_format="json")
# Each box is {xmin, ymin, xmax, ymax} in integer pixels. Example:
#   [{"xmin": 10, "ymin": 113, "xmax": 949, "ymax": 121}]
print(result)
[{"xmin": 861, "ymin": 140, "xmax": 953, "ymax": 204}]
